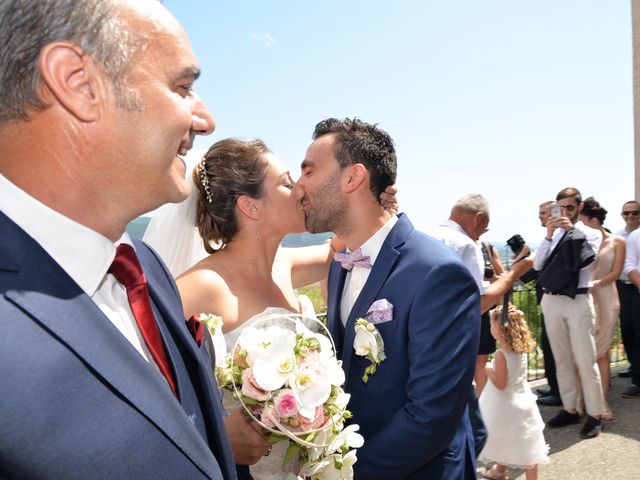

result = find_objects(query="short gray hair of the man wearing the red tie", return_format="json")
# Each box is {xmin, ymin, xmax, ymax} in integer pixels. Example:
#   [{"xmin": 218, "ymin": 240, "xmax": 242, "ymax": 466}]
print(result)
[{"xmin": 0, "ymin": 0, "xmax": 145, "ymax": 123}]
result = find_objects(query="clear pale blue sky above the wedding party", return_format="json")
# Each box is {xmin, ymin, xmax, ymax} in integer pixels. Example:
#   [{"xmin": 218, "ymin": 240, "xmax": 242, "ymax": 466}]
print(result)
[{"xmin": 165, "ymin": 0, "xmax": 634, "ymax": 244}]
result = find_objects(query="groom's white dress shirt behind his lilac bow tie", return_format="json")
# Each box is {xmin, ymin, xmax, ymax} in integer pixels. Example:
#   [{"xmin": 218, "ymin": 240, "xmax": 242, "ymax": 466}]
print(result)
[{"xmin": 340, "ymin": 215, "xmax": 398, "ymax": 325}]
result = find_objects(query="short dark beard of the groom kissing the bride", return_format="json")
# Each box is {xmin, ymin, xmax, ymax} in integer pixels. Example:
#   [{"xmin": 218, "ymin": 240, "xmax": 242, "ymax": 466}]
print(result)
[{"xmin": 305, "ymin": 172, "xmax": 348, "ymax": 235}]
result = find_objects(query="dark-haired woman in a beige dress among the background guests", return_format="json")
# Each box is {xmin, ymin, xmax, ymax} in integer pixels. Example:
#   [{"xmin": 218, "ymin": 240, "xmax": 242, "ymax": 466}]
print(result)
[{"xmin": 580, "ymin": 197, "xmax": 626, "ymax": 421}]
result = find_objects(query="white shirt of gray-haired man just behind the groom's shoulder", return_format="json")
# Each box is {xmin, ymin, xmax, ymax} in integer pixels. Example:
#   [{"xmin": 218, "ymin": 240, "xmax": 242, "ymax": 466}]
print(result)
[{"xmin": 428, "ymin": 220, "xmax": 489, "ymax": 295}]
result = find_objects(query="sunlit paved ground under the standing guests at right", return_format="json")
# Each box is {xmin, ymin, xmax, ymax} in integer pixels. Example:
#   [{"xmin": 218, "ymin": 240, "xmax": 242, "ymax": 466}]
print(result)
[{"xmin": 478, "ymin": 365, "xmax": 640, "ymax": 480}]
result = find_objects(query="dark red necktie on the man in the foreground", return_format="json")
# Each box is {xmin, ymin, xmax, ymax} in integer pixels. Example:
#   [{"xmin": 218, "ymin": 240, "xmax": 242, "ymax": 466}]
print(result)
[{"xmin": 109, "ymin": 243, "xmax": 178, "ymax": 397}]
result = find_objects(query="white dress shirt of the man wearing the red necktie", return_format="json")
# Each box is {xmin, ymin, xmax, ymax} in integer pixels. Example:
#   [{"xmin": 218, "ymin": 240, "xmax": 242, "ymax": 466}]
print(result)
[{"xmin": 0, "ymin": 174, "xmax": 159, "ymax": 370}]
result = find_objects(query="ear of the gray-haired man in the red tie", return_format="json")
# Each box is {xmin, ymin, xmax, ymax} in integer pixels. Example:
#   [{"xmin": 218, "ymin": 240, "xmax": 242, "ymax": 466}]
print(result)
[{"xmin": 39, "ymin": 42, "xmax": 106, "ymax": 122}]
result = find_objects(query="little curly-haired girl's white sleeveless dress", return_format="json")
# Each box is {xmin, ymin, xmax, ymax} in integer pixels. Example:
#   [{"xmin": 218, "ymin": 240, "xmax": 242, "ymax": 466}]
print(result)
[{"xmin": 479, "ymin": 349, "xmax": 549, "ymax": 468}]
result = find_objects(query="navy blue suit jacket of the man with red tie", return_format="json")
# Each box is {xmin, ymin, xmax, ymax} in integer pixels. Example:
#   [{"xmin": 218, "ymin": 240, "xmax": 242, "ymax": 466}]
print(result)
[{"xmin": 0, "ymin": 212, "xmax": 235, "ymax": 479}]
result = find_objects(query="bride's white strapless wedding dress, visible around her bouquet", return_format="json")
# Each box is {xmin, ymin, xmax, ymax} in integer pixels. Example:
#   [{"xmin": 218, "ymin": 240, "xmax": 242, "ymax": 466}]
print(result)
[{"xmin": 222, "ymin": 295, "xmax": 315, "ymax": 480}]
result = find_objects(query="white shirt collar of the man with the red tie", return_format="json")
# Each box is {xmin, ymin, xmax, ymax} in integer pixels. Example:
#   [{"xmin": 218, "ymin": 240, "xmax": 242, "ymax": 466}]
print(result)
[{"xmin": 0, "ymin": 174, "xmax": 132, "ymax": 297}]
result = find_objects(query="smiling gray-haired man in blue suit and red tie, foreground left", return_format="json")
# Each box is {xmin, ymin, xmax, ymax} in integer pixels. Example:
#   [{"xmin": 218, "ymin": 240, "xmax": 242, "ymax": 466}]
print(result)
[{"xmin": 0, "ymin": 0, "xmax": 235, "ymax": 479}]
